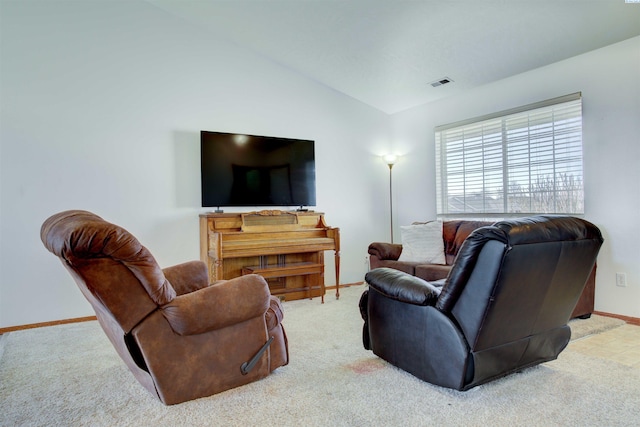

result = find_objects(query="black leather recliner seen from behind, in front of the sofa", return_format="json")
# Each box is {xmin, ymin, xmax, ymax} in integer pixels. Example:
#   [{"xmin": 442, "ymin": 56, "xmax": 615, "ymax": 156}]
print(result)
[{"xmin": 360, "ymin": 216, "xmax": 603, "ymax": 390}]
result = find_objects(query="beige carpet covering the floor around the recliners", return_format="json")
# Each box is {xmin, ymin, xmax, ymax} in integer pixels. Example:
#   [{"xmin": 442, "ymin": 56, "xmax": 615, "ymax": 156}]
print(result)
[{"xmin": 0, "ymin": 286, "xmax": 640, "ymax": 426}]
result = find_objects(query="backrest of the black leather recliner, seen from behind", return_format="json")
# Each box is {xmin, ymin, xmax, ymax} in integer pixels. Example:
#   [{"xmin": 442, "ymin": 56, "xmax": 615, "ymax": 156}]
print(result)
[{"xmin": 436, "ymin": 216, "xmax": 603, "ymax": 351}]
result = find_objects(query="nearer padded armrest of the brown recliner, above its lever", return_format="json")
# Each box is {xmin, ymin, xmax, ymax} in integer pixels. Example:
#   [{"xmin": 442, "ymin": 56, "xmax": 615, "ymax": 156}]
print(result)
[{"xmin": 161, "ymin": 274, "xmax": 271, "ymax": 335}]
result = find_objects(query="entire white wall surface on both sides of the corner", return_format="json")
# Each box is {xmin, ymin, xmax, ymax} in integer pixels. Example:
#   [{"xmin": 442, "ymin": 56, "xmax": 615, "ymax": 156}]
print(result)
[{"xmin": 0, "ymin": 1, "xmax": 640, "ymax": 328}]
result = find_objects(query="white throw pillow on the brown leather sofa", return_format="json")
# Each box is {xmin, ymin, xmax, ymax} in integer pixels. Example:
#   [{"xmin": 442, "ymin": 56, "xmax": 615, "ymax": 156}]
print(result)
[{"xmin": 398, "ymin": 221, "xmax": 445, "ymax": 264}]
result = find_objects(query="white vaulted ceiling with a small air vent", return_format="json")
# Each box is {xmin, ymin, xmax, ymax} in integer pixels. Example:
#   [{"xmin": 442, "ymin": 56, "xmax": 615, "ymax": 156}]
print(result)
[{"xmin": 147, "ymin": 0, "xmax": 640, "ymax": 114}]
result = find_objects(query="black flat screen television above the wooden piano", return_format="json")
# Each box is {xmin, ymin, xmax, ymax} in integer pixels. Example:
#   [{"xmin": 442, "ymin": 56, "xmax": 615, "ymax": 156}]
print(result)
[{"xmin": 200, "ymin": 131, "xmax": 316, "ymax": 209}]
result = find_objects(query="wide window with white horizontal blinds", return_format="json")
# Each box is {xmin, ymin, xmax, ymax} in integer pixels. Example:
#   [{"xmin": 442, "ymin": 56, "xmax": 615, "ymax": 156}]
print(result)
[{"xmin": 435, "ymin": 93, "xmax": 584, "ymax": 217}]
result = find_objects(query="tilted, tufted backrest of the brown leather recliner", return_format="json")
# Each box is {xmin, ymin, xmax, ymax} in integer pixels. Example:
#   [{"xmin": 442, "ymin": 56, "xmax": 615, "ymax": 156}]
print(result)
[{"xmin": 40, "ymin": 210, "xmax": 176, "ymax": 333}]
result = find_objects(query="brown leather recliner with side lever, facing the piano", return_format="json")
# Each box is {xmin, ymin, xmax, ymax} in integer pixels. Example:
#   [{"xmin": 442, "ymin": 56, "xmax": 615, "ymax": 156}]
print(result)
[{"xmin": 40, "ymin": 210, "xmax": 289, "ymax": 405}]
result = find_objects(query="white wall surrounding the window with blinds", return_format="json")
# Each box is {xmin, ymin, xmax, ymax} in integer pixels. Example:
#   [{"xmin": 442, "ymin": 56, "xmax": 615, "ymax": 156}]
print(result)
[{"xmin": 392, "ymin": 37, "xmax": 640, "ymax": 317}]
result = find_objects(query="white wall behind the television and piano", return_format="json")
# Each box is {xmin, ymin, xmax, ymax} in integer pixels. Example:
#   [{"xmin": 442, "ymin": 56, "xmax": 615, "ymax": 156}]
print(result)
[{"xmin": 0, "ymin": 1, "xmax": 389, "ymax": 327}]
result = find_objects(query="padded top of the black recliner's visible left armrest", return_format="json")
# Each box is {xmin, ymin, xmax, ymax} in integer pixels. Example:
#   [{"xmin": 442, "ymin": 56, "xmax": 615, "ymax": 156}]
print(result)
[{"xmin": 365, "ymin": 268, "xmax": 440, "ymax": 305}]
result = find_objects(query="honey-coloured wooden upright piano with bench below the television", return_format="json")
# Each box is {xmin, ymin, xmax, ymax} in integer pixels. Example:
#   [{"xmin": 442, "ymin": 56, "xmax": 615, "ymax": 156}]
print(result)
[{"xmin": 200, "ymin": 210, "xmax": 340, "ymax": 302}]
